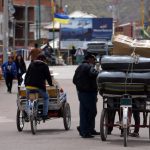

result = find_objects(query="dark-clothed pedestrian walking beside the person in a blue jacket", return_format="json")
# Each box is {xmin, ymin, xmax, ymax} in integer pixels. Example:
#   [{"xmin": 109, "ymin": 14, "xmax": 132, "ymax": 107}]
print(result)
[{"xmin": 15, "ymin": 54, "xmax": 26, "ymax": 85}]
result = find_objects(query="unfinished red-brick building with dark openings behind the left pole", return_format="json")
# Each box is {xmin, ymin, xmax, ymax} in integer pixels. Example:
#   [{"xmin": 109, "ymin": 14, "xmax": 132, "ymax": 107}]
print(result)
[{"xmin": 0, "ymin": 0, "xmax": 59, "ymax": 52}]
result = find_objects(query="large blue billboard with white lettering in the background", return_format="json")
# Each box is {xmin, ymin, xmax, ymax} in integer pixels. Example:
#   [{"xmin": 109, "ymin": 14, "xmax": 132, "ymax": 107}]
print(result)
[{"xmin": 60, "ymin": 18, "xmax": 113, "ymax": 49}]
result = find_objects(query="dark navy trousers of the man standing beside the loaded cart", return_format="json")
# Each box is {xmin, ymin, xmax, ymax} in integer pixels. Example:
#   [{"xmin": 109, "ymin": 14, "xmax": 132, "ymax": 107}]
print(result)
[{"xmin": 78, "ymin": 91, "xmax": 97, "ymax": 135}]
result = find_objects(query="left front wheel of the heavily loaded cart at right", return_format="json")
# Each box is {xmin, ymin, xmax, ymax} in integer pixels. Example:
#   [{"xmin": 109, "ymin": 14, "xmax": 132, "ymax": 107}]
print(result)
[{"xmin": 100, "ymin": 109, "xmax": 108, "ymax": 141}]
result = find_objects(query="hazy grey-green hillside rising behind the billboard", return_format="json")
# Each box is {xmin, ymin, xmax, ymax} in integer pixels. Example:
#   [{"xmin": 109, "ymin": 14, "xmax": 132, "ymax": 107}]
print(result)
[{"xmin": 62, "ymin": 0, "xmax": 150, "ymax": 23}]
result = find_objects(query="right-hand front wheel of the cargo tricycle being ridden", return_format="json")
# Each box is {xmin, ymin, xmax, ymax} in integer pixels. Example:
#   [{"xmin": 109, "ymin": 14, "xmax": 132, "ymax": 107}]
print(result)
[{"xmin": 63, "ymin": 102, "xmax": 71, "ymax": 130}]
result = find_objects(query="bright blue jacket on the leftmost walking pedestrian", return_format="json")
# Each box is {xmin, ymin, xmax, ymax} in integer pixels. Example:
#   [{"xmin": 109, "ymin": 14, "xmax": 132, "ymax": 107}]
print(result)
[{"xmin": 2, "ymin": 61, "xmax": 17, "ymax": 78}]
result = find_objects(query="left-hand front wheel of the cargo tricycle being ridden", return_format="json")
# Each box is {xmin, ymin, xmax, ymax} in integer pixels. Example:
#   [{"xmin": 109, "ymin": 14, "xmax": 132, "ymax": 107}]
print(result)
[{"xmin": 16, "ymin": 108, "xmax": 25, "ymax": 132}]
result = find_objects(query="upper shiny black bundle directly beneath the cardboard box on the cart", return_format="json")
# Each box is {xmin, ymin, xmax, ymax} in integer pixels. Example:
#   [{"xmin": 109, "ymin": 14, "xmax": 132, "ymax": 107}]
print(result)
[{"xmin": 101, "ymin": 55, "xmax": 150, "ymax": 72}]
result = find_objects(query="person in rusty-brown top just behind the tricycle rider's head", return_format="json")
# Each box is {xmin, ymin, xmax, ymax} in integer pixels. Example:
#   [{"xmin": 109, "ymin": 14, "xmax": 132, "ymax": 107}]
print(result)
[{"xmin": 28, "ymin": 43, "xmax": 42, "ymax": 61}]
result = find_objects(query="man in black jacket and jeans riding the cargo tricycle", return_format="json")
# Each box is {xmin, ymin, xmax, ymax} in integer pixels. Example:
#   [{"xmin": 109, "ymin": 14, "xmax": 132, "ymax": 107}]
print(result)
[{"xmin": 25, "ymin": 54, "xmax": 52, "ymax": 119}]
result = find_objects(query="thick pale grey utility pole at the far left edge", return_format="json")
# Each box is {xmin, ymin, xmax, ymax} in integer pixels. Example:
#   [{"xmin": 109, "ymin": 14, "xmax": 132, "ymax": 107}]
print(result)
[{"xmin": 3, "ymin": 0, "xmax": 9, "ymax": 62}]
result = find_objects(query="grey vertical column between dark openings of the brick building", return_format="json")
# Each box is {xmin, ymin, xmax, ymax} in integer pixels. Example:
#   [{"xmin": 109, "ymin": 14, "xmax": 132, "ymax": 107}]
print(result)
[{"xmin": 24, "ymin": 0, "xmax": 29, "ymax": 50}]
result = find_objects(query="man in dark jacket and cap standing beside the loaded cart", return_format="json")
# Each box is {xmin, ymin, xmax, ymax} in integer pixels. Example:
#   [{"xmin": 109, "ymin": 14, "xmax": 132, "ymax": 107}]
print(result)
[{"xmin": 73, "ymin": 54, "xmax": 100, "ymax": 138}]
